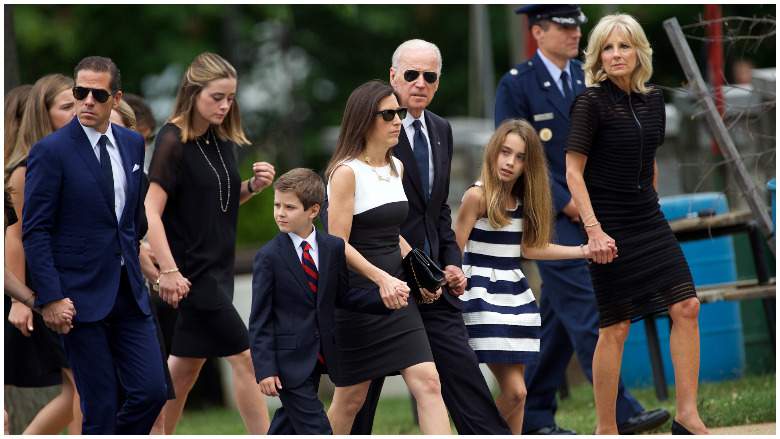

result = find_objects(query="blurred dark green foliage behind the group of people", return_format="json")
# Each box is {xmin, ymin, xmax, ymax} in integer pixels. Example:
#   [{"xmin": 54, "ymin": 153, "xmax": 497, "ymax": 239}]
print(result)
[{"xmin": 5, "ymin": 4, "xmax": 775, "ymax": 247}]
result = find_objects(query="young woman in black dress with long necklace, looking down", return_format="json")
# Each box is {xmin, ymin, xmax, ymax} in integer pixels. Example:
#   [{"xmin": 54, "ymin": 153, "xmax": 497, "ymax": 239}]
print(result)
[{"xmin": 145, "ymin": 53, "xmax": 274, "ymax": 434}]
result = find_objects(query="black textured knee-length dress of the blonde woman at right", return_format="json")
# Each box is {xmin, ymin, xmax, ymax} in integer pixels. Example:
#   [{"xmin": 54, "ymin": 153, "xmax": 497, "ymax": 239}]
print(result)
[{"xmin": 566, "ymin": 79, "xmax": 696, "ymax": 328}]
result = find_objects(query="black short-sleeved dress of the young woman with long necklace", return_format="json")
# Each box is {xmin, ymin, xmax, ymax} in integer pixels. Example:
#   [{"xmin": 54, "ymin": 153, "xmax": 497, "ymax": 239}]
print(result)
[{"xmin": 149, "ymin": 123, "xmax": 249, "ymax": 358}]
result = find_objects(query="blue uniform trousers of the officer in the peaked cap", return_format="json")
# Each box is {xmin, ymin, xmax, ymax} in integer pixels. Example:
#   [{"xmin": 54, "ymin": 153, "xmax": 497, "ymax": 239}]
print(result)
[{"xmin": 523, "ymin": 261, "xmax": 644, "ymax": 433}]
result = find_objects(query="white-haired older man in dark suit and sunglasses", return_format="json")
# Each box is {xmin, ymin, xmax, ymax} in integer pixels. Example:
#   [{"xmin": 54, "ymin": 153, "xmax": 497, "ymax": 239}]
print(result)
[{"xmin": 352, "ymin": 40, "xmax": 511, "ymax": 434}]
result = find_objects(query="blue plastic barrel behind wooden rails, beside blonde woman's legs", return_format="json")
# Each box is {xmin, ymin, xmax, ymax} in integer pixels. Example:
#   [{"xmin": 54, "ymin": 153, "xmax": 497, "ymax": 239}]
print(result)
[{"xmin": 618, "ymin": 192, "xmax": 745, "ymax": 387}]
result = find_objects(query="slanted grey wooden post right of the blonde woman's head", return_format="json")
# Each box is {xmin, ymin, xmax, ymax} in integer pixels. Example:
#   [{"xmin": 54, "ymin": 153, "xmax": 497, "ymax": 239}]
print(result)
[{"xmin": 664, "ymin": 18, "xmax": 776, "ymax": 254}]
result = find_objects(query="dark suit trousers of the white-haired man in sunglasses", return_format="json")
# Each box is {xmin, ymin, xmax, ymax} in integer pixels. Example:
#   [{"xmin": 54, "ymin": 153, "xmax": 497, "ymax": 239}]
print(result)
[{"xmin": 351, "ymin": 298, "xmax": 512, "ymax": 435}]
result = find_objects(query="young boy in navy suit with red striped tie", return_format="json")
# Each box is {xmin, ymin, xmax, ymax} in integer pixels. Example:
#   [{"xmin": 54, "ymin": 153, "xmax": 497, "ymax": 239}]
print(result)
[{"xmin": 249, "ymin": 168, "xmax": 390, "ymax": 434}]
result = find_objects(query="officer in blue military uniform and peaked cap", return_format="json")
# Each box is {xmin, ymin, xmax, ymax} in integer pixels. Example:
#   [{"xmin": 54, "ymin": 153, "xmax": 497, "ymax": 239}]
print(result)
[{"xmin": 495, "ymin": 5, "xmax": 669, "ymax": 434}]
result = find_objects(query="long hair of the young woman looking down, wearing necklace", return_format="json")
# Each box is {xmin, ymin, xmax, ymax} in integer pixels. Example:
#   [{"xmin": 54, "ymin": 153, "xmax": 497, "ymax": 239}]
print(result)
[{"xmin": 169, "ymin": 52, "xmax": 249, "ymax": 145}]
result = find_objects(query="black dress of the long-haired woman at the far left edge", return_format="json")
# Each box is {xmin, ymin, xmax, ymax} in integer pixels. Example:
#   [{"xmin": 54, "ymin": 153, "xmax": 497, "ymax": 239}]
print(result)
[{"xmin": 3, "ymin": 170, "xmax": 69, "ymax": 387}]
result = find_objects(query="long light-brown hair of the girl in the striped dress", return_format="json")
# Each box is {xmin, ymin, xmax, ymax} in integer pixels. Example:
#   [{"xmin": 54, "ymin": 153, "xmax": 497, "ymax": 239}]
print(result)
[{"xmin": 480, "ymin": 119, "xmax": 553, "ymax": 247}]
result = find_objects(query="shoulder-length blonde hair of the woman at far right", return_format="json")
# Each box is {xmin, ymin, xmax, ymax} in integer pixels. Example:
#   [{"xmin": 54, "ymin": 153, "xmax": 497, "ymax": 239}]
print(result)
[{"xmin": 583, "ymin": 14, "xmax": 653, "ymax": 93}]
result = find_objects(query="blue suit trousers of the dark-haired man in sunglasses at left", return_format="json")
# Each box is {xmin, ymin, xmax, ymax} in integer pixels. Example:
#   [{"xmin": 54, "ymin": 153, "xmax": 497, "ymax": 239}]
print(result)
[{"xmin": 64, "ymin": 268, "xmax": 168, "ymax": 435}]
